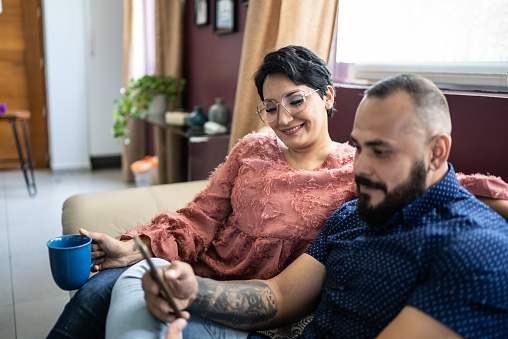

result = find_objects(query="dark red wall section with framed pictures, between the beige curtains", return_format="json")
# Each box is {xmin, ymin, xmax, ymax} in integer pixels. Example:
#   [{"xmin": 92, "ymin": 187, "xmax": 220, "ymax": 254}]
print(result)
[{"xmin": 183, "ymin": 0, "xmax": 248, "ymax": 122}]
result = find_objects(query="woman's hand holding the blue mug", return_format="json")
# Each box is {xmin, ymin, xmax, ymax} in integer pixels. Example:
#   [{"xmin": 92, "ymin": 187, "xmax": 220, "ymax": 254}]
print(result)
[{"xmin": 79, "ymin": 228, "xmax": 143, "ymax": 272}]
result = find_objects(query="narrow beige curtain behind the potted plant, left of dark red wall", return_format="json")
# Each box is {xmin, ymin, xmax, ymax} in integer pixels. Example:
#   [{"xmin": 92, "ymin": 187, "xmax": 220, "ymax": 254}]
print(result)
[{"xmin": 154, "ymin": 0, "xmax": 186, "ymax": 183}]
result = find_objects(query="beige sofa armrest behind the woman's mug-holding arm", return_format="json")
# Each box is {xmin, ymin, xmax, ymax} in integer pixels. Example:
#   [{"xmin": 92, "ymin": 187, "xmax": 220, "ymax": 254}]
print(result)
[{"xmin": 62, "ymin": 180, "xmax": 208, "ymax": 237}]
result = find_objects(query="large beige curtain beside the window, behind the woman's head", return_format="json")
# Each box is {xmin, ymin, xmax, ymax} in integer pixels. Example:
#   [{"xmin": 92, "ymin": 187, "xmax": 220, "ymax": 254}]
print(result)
[{"xmin": 229, "ymin": 0, "xmax": 339, "ymax": 148}]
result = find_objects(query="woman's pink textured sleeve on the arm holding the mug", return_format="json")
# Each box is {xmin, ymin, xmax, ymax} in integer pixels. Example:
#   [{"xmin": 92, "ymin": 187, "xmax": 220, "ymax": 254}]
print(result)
[{"xmin": 120, "ymin": 135, "xmax": 245, "ymax": 262}]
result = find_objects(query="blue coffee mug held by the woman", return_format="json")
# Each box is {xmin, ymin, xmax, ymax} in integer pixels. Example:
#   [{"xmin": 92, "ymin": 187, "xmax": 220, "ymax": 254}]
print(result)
[{"xmin": 46, "ymin": 234, "xmax": 95, "ymax": 291}]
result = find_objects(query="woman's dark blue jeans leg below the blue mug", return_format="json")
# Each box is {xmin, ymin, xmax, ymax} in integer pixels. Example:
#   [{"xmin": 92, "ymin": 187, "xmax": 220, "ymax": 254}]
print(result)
[{"xmin": 47, "ymin": 267, "xmax": 129, "ymax": 339}]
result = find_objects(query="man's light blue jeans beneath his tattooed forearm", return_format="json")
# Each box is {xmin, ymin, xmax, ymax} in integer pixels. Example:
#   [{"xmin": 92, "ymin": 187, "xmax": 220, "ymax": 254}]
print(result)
[{"xmin": 106, "ymin": 258, "xmax": 249, "ymax": 339}]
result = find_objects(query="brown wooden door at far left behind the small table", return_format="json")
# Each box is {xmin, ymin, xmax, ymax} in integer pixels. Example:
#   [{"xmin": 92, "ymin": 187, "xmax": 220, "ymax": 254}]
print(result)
[{"xmin": 0, "ymin": 0, "xmax": 49, "ymax": 168}]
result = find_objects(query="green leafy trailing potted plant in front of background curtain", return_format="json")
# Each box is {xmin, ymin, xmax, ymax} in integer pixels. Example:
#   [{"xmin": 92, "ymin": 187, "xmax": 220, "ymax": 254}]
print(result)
[{"xmin": 112, "ymin": 75, "xmax": 185, "ymax": 140}]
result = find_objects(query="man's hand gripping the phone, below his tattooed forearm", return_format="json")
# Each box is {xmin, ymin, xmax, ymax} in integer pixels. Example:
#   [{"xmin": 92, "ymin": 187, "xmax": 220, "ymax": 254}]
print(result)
[{"xmin": 141, "ymin": 260, "xmax": 198, "ymax": 322}]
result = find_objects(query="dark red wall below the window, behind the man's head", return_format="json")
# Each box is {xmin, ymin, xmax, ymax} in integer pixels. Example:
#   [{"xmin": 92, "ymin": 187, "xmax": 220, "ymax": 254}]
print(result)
[{"xmin": 330, "ymin": 87, "xmax": 508, "ymax": 181}]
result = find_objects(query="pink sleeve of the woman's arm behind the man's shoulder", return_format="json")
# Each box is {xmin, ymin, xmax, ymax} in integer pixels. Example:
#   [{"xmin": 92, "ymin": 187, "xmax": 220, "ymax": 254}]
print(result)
[{"xmin": 457, "ymin": 173, "xmax": 508, "ymax": 200}]
